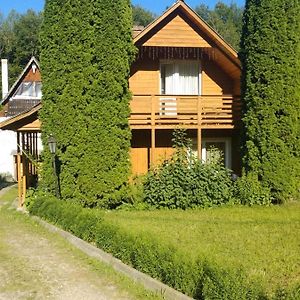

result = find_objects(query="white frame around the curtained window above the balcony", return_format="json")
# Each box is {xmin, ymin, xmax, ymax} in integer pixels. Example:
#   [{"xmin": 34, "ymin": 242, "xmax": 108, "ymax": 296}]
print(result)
[{"xmin": 158, "ymin": 59, "xmax": 202, "ymax": 96}]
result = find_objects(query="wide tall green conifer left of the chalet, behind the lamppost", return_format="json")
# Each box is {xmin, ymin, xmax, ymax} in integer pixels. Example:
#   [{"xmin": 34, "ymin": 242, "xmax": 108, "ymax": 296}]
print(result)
[{"xmin": 40, "ymin": 0, "xmax": 134, "ymax": 207}]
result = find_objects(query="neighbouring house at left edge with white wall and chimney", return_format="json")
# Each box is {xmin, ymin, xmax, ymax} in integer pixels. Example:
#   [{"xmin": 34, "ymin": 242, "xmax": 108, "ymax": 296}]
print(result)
[{"xmin": 0, "ymin": 57, "xmax": 42, "ymax": 179}]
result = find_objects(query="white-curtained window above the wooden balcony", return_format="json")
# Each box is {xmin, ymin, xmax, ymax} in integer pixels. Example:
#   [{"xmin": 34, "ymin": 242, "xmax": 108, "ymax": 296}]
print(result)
[{"xmin": 160, "ymin": 61, "xmax": 201, "ymax": 95}]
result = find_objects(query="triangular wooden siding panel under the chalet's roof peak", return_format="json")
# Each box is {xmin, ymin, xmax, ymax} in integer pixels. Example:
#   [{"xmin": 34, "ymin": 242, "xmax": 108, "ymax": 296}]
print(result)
[{"xmin": 144, "ymin": 15, "xmax": 211, "ymax": 47}]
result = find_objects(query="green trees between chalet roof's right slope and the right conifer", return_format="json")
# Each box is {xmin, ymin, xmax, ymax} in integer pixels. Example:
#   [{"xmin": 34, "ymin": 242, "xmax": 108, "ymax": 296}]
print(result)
[{"xmin": 195, "ymin": 1, "xmax": 243, "ymax": 50}]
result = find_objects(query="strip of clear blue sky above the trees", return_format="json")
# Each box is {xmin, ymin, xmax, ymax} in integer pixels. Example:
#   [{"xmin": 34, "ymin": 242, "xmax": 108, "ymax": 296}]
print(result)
[{"xmin": 0, "ymin": 0, "xmax": 245, "ymax": 16}]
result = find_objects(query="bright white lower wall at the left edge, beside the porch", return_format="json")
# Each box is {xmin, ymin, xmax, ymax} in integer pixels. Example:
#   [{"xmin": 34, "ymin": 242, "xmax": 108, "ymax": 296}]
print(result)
[{"xmin": 0, "ymin": 117, "xmax": 17, "ymax": 176}]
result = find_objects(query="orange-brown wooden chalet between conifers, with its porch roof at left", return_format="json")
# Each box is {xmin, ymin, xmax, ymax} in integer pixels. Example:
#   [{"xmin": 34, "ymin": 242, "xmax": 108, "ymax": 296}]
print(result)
[{"xmin": 0, "ymin": 1, "xmax": 241, "ymax": 205}]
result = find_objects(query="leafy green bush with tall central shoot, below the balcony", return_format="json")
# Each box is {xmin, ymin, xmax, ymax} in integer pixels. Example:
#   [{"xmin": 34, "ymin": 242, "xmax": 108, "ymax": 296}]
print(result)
[{"xmin": 144, "ymin": 130, "xmax": 232, "ymax": 209}]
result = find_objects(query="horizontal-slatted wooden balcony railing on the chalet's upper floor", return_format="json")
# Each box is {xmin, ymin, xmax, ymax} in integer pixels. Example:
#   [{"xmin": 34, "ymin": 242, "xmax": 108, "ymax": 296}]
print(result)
[{"xmin": 129, "ymin": 95, "xmax": 241, "ymax": 129}]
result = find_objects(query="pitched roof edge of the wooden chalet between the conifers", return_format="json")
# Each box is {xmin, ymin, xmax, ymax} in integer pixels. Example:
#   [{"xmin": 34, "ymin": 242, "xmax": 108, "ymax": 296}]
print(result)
[{"xmin": 133, "ymin": 0, "xmax": 240, "ymax": 73}]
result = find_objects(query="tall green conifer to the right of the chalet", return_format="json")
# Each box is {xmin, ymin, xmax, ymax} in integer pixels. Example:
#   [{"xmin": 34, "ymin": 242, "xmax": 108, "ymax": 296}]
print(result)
[{"xmin": 240, "ymin": 0, "xmax": 300, "ymax": 201}]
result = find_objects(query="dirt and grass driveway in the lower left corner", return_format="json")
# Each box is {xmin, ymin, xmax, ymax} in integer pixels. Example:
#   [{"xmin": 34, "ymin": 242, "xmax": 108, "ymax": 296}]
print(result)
[{"xmin": 0, "ymin": 186, "xmax": 158, "ymax": 300}]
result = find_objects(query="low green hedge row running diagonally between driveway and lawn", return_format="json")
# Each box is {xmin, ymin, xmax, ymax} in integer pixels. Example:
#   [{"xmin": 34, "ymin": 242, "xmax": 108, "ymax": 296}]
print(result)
[{"xmin": 29, "ymin": 196, "xmax": 296, "ymax": 300}]
